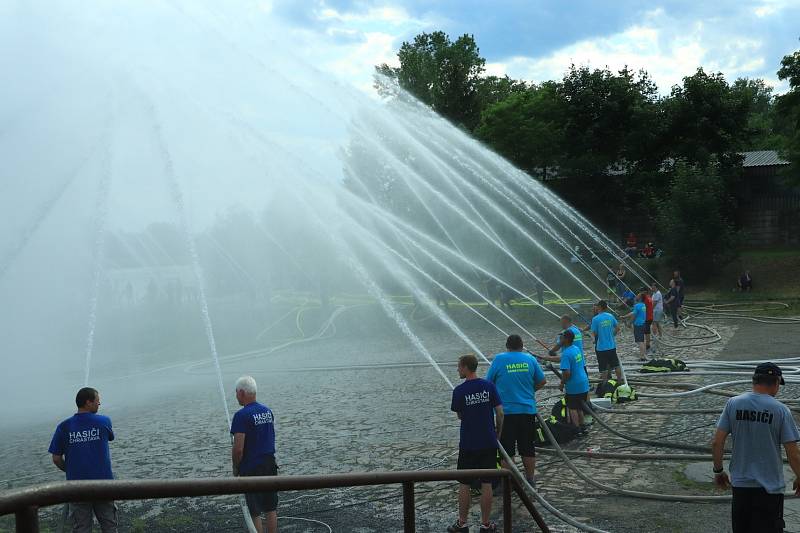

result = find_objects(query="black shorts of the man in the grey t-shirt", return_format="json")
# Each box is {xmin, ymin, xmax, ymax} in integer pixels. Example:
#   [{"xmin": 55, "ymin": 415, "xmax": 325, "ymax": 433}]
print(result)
[{"xmin": 731, "ymin": 487, "xmax": 785, "ymax": 533}]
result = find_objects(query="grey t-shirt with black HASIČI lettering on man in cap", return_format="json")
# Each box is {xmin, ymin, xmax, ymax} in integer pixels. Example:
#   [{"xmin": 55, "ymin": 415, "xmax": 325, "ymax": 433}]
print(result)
[{"xmin": 717, "ymin": 392, "xmax": 800, "ymax": 494}]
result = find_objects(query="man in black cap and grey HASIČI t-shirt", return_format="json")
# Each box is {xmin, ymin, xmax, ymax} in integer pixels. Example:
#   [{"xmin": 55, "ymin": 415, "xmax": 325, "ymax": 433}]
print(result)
[{"xmin": 711, "ymin": 363, "xmax": 800, "ymax": 533}]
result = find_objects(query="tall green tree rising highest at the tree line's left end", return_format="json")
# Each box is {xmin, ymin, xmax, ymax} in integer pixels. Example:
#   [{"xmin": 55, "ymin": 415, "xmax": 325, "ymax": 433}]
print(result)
[{"xmin": 376, "ymin": 31, "xmax": 486, "ymax": 131}]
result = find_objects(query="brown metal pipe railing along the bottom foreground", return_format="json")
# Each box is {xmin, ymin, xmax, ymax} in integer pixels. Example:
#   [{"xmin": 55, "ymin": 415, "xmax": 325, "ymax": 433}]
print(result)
[{"xmin": 0, "ymin": 469, "xmax": 549, "ymax": 533}]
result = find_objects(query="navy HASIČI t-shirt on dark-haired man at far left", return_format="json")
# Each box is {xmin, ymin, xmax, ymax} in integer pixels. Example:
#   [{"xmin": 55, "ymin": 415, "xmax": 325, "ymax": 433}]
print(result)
[{"xmin": 48, "ymin": 413, "xmax": 114, "ymax": 480}]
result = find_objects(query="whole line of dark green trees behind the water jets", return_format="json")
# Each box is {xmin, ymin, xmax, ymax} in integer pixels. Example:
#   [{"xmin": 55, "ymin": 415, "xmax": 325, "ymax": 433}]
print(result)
[{"xmin": 376, "ymin": 31, "xmax": 800, "ymax": 278}]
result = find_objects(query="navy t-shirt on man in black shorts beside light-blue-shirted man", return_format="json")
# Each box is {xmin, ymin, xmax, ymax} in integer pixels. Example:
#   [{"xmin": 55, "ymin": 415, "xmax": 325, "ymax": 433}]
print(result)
[{"xmin": 450, "ymin": 378, "xmax": 502, "ymax": 450}]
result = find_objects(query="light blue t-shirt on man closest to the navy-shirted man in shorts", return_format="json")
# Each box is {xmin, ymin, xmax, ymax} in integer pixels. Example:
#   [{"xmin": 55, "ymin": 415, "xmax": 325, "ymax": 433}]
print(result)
[{"xmin": 486, "ymin": 352, "xmax": 544, "ymax": 415}]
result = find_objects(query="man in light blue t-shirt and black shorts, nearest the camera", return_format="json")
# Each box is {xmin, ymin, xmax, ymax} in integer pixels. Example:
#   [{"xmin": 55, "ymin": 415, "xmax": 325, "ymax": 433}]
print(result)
[{"xmin": 486, "ymin": 335, "xmax": 547, "ymax": 482}]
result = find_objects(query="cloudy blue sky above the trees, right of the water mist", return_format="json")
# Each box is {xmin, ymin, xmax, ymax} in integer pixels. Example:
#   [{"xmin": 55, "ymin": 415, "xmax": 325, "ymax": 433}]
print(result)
[{"xmin": 260, "ymin": 0, "xmax": 800, "ymax": 94}]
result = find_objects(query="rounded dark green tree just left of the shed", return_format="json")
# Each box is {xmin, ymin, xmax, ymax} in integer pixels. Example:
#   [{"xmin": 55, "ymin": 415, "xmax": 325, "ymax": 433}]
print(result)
[{"xmin": 656, "ymin": 161, "xmax": 737, "ymax": 281}]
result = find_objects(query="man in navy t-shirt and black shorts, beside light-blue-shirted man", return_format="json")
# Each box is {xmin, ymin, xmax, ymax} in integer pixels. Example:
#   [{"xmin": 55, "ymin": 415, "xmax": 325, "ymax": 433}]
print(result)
[{"xmin": 447, "ymin": 354, "xmax": 503, "ymax": 533}]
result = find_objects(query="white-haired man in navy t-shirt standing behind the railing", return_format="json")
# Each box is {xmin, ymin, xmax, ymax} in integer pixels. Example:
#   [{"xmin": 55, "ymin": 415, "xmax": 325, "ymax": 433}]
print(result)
[{"xmin": 231, "ymin": 376, "xmax": 278, "ymax": 533}]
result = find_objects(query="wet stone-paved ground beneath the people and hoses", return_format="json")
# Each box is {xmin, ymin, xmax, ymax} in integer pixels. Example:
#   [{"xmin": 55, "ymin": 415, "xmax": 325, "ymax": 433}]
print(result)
[{"xmin": 0, "ymin": 308, "xmax": 800, "ymax": 533}]
